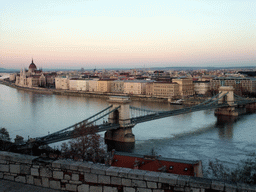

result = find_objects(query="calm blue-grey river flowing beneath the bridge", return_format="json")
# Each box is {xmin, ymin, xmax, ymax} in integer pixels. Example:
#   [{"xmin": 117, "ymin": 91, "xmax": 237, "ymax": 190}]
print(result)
[{"xmin": 0, "ymin": 77, "xmax": 256, "ymax": 172}]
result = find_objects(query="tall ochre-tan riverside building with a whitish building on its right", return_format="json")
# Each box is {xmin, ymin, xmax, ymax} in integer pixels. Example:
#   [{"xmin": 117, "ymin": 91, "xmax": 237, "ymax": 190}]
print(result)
[{"xmin": 172, "ymin": 78, "xmax": 194, "ymax": 97}]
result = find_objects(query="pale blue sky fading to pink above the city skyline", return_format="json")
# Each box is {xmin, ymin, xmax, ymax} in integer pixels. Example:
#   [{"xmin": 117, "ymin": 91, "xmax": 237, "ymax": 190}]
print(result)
[{"xmin": 0, "ymin": 0, "xmax": 256, "ymax": 69}]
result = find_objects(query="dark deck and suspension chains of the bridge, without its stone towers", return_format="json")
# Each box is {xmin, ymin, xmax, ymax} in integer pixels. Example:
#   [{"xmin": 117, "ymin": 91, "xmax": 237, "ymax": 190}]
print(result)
[{"xmin": 16, "ymin": 93, "xmax": 256, "ymax": 146}]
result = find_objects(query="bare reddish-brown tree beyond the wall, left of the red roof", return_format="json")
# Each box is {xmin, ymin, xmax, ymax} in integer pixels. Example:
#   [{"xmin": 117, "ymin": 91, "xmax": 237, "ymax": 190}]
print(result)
[{"xmin": 61, "ymin": 126, "xmax": 106, "ymax": 162}]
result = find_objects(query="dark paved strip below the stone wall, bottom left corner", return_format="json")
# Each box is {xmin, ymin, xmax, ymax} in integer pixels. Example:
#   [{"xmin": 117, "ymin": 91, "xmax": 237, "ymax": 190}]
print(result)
[{"xmin": 0, "ymin": 179, "xmax": 63, "ymax": 192}]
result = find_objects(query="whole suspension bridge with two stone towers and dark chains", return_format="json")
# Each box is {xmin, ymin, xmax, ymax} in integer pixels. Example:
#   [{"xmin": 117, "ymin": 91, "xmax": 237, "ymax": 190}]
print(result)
[{"xmin": 15, "ymin": 86, "xmax": 256, "ymax": 150}]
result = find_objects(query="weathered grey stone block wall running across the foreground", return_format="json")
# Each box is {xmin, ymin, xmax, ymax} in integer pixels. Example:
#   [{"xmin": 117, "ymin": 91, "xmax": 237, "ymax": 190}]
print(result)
[{"xmin": 0, "ymin": 151, "xmax": 256, "ymax": 192}]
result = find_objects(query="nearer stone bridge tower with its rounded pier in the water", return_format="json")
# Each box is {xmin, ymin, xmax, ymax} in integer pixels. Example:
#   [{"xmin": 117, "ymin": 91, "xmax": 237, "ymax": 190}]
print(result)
[{"xmin": 105, "ymin": 96, "xmax": 135, "ymax": 151}]
